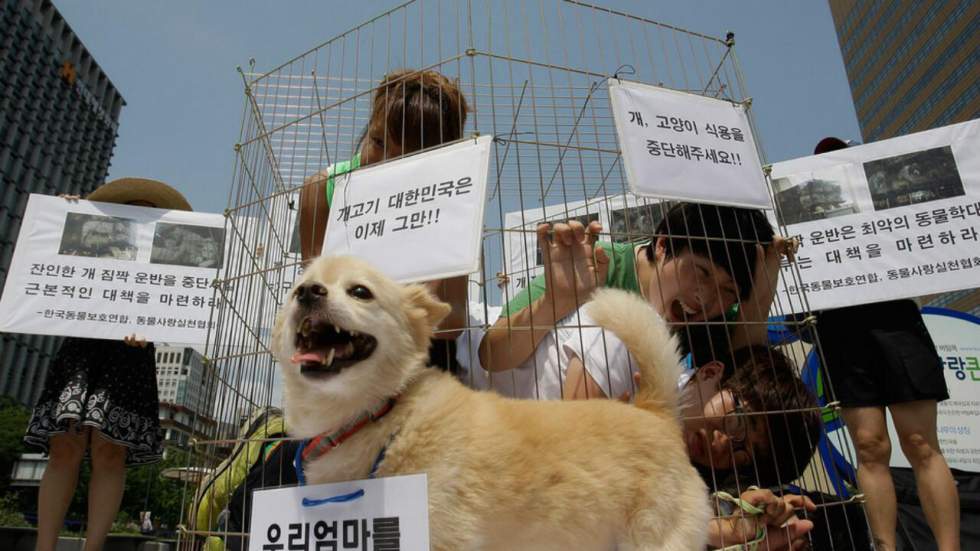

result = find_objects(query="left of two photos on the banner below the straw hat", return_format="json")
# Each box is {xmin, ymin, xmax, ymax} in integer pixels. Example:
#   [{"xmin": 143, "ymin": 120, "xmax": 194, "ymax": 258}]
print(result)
[{"xmin": 58, "ymin": 212, "xmax": 137, "ymax": 260}]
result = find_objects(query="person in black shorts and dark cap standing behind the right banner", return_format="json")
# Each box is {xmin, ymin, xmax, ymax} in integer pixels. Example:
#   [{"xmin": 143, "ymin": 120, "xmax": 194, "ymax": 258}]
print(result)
[{"xmin": 814, "ymin": 138, "xmax": 960, "ymax": 551}]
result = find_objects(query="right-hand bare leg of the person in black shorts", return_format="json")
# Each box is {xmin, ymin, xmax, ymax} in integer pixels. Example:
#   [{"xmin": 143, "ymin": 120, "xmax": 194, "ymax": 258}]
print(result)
[{"xmin": 888, "ymin": 400, "xmax": 960, "ymax": 551}]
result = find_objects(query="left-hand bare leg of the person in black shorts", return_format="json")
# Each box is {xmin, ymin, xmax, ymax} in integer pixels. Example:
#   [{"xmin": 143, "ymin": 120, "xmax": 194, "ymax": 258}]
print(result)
[{"xmin": 841, "ymin": 406, "xmax": 897, "ymax": 551}]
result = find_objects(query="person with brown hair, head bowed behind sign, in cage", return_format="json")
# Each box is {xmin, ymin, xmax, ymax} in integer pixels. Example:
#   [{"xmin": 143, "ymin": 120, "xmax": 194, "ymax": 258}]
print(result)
[{"xmin": 299, "ymin": 69, "xmax": 469, "ymax": 371}]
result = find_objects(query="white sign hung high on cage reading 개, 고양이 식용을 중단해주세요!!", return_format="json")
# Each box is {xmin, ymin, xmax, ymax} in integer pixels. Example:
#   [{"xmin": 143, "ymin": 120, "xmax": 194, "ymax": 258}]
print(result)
[{"xmin": 609, "ymin": 79, "xmax": 772, "ymax": 209}]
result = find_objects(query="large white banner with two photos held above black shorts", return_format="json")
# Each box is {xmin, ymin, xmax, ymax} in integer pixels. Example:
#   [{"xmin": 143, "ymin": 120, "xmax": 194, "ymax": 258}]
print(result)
[{"xmin": 772, "ymin": 120, "xmax": 980, "ymax": 312}]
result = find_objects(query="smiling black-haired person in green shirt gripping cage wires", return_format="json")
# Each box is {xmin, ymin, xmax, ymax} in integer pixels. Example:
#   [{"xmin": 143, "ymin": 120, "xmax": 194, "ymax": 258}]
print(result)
[{"xmin": 479, "ymin": 203, "xmax": 775, "ymax": 372}]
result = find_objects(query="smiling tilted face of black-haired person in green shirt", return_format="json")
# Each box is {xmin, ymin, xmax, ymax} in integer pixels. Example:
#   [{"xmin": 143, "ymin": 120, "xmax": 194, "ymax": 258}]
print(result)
[{"xmin": 647, "ymin": 238, "xmax": 738, "ymax": 323}]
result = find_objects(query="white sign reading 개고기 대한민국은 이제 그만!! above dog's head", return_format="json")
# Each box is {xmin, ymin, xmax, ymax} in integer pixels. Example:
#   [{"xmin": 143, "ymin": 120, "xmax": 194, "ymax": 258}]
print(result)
[{"xmin": 323, "ymin": 136, "xmax": 493, "ymax": 283}]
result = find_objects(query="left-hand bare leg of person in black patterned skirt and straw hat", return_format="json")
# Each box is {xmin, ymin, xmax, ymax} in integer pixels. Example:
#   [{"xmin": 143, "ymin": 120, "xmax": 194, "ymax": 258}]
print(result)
[{"xmin": 37, "ymin": 425, "xmax": 86, "ymax": 551}]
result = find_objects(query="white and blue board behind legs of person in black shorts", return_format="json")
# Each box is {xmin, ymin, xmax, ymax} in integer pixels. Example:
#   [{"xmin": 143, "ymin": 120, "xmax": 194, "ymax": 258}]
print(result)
[{"xmin": 888, "ymin": 308, "xmax": 980, "ymax": 473}]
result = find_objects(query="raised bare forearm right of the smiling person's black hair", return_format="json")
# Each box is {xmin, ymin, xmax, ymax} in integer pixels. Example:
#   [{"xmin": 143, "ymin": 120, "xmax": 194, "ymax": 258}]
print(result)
[{"xmin": 732, "ymin": 235, "xmax": 799, "ymax": 350}]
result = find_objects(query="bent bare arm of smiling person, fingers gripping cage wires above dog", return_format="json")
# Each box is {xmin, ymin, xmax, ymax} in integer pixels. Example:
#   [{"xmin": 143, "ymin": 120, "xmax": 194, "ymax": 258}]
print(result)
[{"xmin": 479, "ymin": 221, "xmax": 609, "ymax": 372}]
